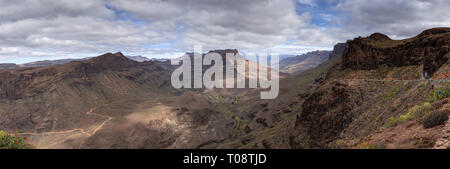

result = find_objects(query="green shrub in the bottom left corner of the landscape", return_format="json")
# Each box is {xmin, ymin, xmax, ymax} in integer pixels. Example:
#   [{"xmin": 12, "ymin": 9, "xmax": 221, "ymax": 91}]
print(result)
[{"xmin": 0, "ymin": 130, "xmax": 33, "ymax": 149}]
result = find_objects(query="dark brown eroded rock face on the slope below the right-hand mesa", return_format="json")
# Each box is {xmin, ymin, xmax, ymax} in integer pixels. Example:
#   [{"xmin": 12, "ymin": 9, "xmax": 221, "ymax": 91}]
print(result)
[{"xmin": 291, "ymin": 82, "xmax": 363, "ymax": 148}]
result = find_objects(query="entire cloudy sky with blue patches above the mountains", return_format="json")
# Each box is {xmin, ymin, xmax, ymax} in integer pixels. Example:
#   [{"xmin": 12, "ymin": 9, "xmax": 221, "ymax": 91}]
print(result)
[{"xmin": 0, "ymin": 0, "xmax": 450, "ymax": 63}]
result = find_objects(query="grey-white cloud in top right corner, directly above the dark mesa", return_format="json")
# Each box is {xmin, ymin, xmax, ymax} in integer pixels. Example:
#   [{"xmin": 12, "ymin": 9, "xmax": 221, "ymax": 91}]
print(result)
[{"xmin": 335, "ymin": 0, "xmax": 450, "ymax": 38}]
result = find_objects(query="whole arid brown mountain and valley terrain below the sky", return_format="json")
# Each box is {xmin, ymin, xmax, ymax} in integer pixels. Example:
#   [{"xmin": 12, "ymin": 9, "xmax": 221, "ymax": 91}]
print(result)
[{"xmin": 0, "ymin": 28, "xmax": 450, "ymax": 149}]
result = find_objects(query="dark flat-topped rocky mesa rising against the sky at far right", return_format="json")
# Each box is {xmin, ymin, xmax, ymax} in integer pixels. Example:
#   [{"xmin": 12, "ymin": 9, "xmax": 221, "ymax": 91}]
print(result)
[{"xmin": 342, "ymin": 28, "xmax": 450, "ymax": 77}]
